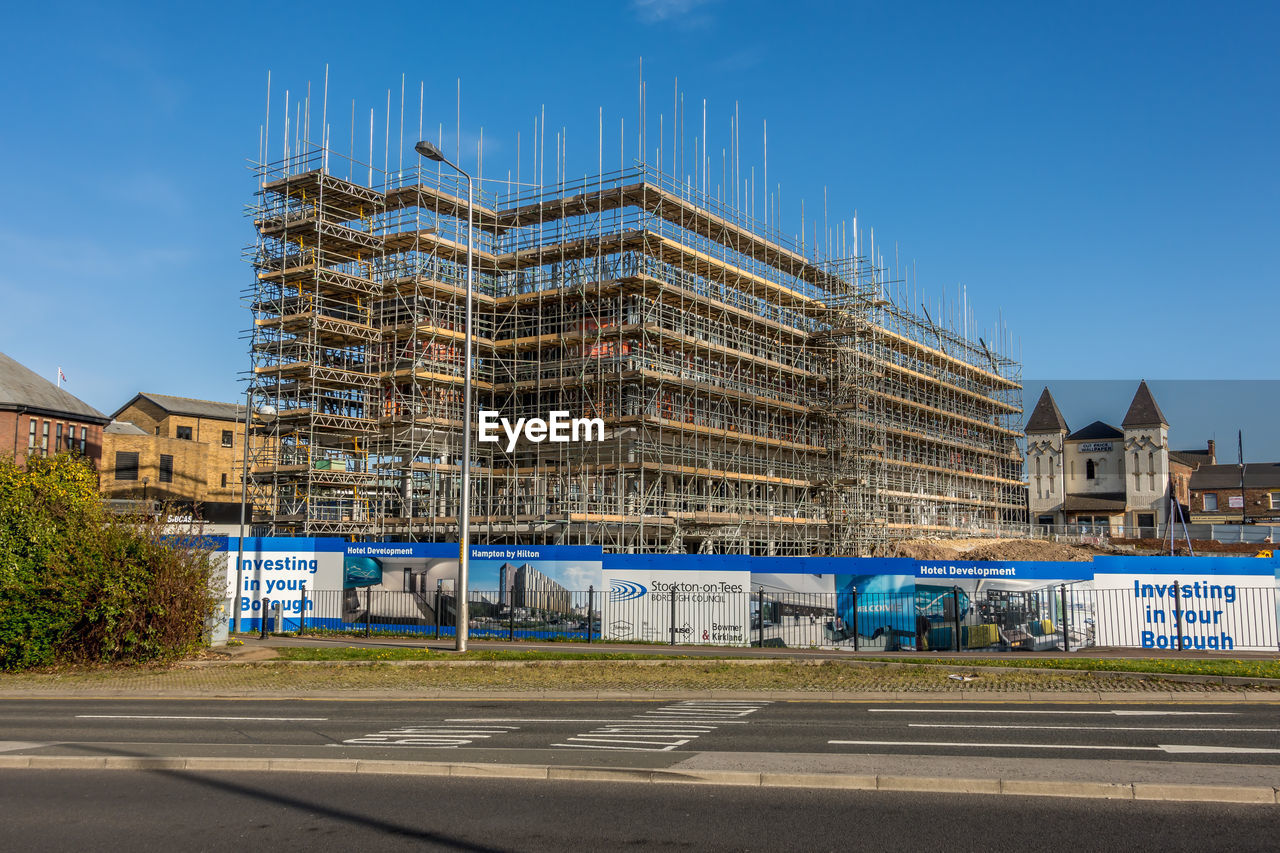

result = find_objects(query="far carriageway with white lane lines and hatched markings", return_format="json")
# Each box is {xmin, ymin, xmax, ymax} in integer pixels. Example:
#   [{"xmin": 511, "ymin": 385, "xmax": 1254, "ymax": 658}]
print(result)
[{"xmin": 0, "ymin": 699, "xmax": 1280, "ymax": 768}]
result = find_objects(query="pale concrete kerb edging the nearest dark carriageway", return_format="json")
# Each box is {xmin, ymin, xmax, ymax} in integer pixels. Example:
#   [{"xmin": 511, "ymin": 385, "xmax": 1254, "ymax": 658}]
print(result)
[{"xmin": 0, "ymin": 756, "xmax": 1280, "ymax": 806}]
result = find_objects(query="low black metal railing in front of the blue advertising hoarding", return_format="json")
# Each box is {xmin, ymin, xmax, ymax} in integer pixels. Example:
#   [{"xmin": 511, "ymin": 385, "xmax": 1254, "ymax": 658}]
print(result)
[{"xmin": 244, "ymin": 580, "xmax": 1280, "ymax": 652}]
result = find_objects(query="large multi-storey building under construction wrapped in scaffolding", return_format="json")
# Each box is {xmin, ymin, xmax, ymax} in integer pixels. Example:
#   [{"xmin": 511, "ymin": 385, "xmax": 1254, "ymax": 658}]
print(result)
[{"xmin": 247, "ymin": 135, "xmax": 1025, "ymax": 556}]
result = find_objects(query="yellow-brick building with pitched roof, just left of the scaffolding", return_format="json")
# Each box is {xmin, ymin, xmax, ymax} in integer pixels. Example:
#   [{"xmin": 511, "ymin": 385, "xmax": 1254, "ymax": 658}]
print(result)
[{"xmin": 101, "ymin": 393, "xmax": 244, "ymax": 529}]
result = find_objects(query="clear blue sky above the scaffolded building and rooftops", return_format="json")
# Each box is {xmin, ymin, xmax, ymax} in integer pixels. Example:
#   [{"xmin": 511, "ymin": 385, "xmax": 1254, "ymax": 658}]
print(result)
[{"xmin": 0, "ymin": 0, "xmax": 1280, "ymax": 441}]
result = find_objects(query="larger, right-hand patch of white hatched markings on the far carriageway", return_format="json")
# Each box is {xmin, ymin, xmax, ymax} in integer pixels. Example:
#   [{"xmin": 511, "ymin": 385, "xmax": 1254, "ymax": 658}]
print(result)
[{"xmin": 552, "ymin": 699, "xmax": 772, "ymax": 752}]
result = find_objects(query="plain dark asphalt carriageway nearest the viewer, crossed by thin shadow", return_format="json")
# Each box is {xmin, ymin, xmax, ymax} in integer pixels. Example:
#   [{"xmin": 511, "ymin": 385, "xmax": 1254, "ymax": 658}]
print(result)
[{"xmin": 0, "ymin": 771, "xmax": 1280, "ymax": 853}]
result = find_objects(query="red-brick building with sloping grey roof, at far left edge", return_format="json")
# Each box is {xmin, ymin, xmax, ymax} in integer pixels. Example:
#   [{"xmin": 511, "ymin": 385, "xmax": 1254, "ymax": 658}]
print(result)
[{"xmin": 0, "ymin": 352, "xmax": 110, "ymax": 466}]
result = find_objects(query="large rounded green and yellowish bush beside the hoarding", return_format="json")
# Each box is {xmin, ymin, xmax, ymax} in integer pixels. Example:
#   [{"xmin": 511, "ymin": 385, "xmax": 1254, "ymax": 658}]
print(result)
[{"xmin": 0, "ymin": 453, "xmax": 216, "ymax": 670}]
